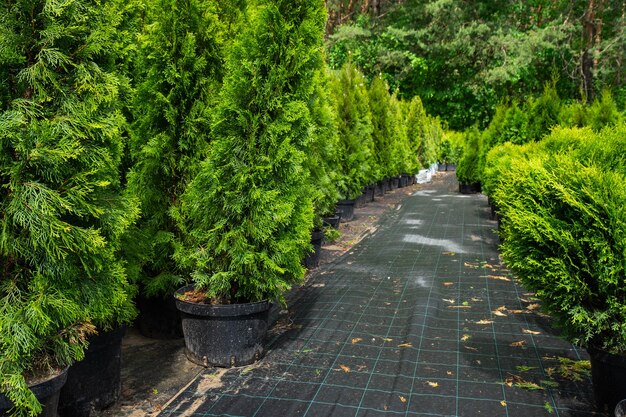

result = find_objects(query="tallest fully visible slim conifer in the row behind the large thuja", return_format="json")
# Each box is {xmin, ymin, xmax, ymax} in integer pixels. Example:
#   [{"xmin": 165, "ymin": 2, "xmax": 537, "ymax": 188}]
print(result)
[{"xmin": 332, "ymin": 62, "xmax": 376, "ymax": 199}]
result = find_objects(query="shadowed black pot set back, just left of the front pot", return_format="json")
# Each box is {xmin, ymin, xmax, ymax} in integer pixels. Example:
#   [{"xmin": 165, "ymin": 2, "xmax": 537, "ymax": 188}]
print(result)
[{"xmin": 135, "ymin": 295, "xmax": 183, "ymax": 340}]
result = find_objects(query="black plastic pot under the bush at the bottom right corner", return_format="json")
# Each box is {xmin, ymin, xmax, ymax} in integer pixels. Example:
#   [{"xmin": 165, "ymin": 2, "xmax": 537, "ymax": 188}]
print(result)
[{"xmin": 587, "ymin": 347, "xmax": 626, "ymax": 413}]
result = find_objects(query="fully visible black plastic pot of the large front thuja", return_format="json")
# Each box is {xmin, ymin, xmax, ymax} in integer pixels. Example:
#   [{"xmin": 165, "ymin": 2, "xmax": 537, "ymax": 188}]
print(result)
[{"xmin": 176, "ymin": 285, "xmax": 270, "ymax": 368}]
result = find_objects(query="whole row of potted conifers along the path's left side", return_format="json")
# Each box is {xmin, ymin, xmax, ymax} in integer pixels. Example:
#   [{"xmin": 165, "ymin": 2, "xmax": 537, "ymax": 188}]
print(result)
[{"xmin": 0, "ymin": 0, "xmax": 441, "ymax": 416}]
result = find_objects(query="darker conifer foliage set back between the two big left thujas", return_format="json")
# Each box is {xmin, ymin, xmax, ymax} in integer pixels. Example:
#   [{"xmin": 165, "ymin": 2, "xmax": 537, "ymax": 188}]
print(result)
[{"xmin": 124, "ymin": 0, "xmax": 229, "ymax": 296}]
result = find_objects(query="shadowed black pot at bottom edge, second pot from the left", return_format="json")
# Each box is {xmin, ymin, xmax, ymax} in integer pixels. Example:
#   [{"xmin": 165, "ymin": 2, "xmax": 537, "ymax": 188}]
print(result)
[{"xmin": 59, "ymin": 326, "xmax": 126, "ymax": 417}]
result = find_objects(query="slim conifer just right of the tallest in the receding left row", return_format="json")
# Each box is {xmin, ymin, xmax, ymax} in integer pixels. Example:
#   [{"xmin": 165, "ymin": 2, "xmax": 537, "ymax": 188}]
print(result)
[{"xmin": 368, "ymin": 77, "xmax": 398, "ymax": 180}]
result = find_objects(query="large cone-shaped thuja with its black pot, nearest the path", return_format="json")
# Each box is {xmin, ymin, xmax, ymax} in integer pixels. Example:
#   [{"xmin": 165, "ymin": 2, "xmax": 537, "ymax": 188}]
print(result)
[{"xmin": 174, "ymin": 0, "xmax": 325, "ymax": 367}]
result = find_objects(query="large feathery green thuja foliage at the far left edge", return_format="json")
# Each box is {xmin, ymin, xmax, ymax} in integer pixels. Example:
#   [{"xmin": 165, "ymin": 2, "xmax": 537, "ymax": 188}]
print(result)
[{"xmin": 0, "ymin": 0, "xmax": 137, "ymax": 416}]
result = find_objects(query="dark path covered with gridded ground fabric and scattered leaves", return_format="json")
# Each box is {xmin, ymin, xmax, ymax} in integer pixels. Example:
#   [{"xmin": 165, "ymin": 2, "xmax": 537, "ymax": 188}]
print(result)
[{"xmin": 159, "ymin": 174, "xmax": 598, "ymax": 417}]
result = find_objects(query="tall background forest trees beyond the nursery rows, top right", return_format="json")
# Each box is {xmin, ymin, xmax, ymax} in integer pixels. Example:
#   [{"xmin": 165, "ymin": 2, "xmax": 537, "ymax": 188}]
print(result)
[{"xmin": 327, "ymin": 0, "xmax": 626, "ymax": 130}]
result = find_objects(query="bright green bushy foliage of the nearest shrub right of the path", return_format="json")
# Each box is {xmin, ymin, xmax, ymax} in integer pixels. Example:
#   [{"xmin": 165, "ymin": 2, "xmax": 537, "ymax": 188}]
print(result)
[{"xmin": 487, "ymin": 124, "xmax": 626, "ymax": 354}]
